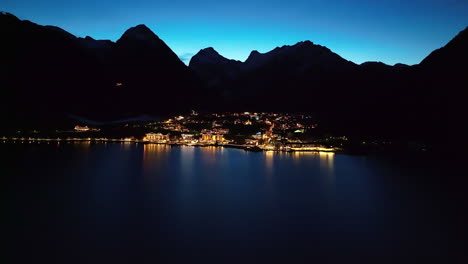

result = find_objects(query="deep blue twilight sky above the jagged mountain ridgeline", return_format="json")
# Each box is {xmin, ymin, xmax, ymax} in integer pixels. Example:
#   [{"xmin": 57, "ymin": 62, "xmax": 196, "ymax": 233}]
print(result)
[{"xmin": 0, "ymin": 0, "xmax": 468, "ymax": 64}]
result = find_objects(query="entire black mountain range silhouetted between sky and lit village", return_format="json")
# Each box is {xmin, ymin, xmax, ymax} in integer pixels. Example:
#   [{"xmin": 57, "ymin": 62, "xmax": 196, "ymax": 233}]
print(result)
[{"xmin": 0, "ymin": 13, "xmax": 468, "ymax": 144}]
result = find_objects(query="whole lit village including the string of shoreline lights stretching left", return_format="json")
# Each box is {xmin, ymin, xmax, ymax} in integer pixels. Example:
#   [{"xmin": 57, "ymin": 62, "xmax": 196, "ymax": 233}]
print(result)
[{"xmin": 1, "ymin": 111, "xmax": 347, "ymax": 152}]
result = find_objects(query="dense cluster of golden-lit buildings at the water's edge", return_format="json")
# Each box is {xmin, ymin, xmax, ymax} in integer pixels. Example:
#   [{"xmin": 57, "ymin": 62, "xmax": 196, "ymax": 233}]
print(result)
[{"xmin": 143, "ymin": 112, "xmax": 342, "ymax": 150}]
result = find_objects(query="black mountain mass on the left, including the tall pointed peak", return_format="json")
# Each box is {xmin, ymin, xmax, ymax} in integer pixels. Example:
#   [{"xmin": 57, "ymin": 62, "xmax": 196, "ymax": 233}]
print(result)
[{"xmin": 0, "ymin": 13, "xmax": 198, "ymax": 129}]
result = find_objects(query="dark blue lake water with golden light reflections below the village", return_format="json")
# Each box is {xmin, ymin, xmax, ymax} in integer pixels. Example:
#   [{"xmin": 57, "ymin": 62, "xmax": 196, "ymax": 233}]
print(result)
[{"xmin": 0, "ymin": 143, "xmax": 467, "ymax": 263}]
